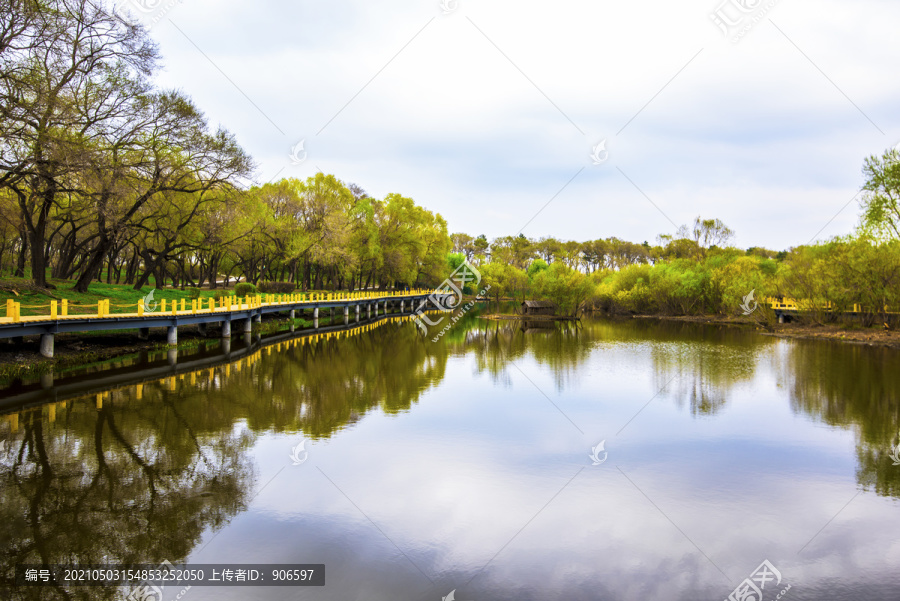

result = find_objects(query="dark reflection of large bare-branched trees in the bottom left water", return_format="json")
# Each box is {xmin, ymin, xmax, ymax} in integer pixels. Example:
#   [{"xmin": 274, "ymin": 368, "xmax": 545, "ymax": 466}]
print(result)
[{"xmin": 0, "ymin": 386, "xmax": 253, "ymax": 599}]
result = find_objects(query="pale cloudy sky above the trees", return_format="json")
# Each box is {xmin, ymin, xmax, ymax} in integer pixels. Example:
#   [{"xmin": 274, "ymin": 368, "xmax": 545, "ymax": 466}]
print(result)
[{"xmin": 118, "ymin": 0, "xmax": 900, "ymax": 250}]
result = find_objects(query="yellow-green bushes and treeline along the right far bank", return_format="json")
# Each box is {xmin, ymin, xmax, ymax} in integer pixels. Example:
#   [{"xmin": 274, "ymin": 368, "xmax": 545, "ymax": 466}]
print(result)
[{"xmin": 451, "ymin": 186, "xmax": 900, "ymax": 325}]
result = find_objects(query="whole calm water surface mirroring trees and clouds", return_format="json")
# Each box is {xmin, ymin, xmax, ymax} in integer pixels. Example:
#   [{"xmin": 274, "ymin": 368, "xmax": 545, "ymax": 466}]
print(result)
[{"xmin": 0, "ymin": 315, "xmax": 900, "ymax": 601}]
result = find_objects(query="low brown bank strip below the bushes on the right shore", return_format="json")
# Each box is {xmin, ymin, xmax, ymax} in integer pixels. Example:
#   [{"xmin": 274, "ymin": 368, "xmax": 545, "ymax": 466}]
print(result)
[{"xmin": 633, "ymin": 315, "xmax": 900, "ymax": 349}]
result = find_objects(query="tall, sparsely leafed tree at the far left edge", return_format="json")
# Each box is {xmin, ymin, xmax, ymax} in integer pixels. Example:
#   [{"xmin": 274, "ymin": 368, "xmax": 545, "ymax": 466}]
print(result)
[{"xmin": 0, "ymin": 0, "xmax": 157, "ymax": 287}]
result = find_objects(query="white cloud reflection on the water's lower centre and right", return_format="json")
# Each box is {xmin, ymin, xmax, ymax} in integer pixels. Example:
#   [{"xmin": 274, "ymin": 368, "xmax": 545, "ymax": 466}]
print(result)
[{"xmin": 241, "ymin": 424, "xmax": 895, "ymax": 599}]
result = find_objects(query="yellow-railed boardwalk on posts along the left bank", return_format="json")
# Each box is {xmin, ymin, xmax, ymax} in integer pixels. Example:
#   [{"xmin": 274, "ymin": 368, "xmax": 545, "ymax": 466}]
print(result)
[{"xmin": 0, "ymin": 290, "xmax": 449, "ymax": 357}]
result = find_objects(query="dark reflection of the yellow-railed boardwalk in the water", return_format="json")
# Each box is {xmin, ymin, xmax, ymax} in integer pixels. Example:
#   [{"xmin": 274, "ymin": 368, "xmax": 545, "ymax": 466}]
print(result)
[{"xmin": 0, "ymin": 313, "xmax": 432, "ymax": 414}]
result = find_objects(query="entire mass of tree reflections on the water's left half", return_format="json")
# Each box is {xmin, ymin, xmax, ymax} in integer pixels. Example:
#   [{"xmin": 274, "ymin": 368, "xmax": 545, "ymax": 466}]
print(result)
[{"xmin": 0, "ymin": 319, "xmax": 447, "ymax": 600}]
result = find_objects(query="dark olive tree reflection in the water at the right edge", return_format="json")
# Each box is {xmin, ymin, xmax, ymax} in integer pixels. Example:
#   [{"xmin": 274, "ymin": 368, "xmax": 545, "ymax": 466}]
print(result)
[{"xmin": 782, "ymin": 342, "xmax": 900, "ymax": 497}]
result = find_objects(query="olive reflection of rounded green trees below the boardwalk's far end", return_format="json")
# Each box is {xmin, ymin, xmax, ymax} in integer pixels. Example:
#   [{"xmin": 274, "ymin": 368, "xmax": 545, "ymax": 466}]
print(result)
[{"xmin": 184, "ymin": 321, "xmax": 447, "ymax": 438}]
